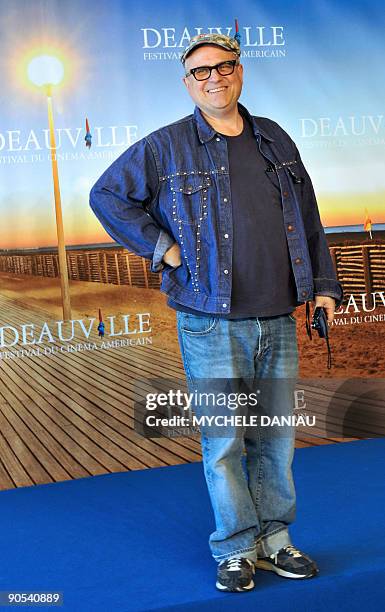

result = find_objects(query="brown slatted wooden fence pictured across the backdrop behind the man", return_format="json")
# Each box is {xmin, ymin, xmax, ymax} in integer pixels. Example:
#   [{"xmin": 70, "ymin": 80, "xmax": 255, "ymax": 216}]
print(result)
[{"xmin": 0, "ymin": 243, "xmax": 385, "ymax": 296}]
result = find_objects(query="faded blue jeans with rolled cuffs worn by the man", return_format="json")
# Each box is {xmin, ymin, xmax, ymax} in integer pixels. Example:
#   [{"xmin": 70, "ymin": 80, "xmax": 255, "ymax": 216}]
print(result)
[{"xmin": 177, "ymin": 312, "xmax": 298, "ymax": 561}]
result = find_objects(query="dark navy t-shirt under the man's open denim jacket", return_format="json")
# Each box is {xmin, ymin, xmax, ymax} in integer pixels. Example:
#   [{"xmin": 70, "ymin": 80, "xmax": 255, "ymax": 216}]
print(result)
[{"xmin": 168, "ymin": 119, "xmax": 297, "ymax": 319}]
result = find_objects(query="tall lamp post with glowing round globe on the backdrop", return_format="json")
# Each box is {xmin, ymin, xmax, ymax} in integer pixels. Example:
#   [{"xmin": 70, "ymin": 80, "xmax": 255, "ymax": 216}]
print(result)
[{"xmin": 28, "ymin": 55, "xmax": 71, "ymax": 321}]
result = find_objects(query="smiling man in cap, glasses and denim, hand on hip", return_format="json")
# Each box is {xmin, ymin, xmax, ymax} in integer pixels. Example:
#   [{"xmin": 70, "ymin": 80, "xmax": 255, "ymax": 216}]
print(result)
[{"xmin": 91, "ymin": 34, "xmax": 342, "ymax": 592}]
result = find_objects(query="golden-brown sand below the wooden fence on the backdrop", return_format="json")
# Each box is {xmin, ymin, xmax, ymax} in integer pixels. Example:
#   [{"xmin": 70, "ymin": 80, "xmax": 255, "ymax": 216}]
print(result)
[{"xmin": 0, "ymin": 273, "xmax": 385, "ymax": 378}]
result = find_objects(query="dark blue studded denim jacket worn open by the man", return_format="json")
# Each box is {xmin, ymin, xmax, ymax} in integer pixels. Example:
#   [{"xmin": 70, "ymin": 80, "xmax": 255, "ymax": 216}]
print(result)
[{"xmin": 90, "ymin": 104, "xmax": 342, "ymax": 314}]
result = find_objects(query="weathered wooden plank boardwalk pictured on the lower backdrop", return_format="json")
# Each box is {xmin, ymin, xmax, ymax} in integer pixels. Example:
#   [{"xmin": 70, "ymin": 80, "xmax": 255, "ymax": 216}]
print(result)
[{"xmin": 0, "ymin": 296, "xmax": 385, "ymax": 489}]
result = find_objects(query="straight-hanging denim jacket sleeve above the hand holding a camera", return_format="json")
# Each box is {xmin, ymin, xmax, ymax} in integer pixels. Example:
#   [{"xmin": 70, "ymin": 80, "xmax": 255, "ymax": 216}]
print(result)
[{"xmin": 295, "ymin": 150, "xmax": 343, "ymax": 308}]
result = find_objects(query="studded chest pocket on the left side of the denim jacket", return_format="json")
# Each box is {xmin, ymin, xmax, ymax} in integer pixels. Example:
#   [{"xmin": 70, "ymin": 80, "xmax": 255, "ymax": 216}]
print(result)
[{"xmin": 170, "ymin": 174, "xmax": 212, "ymax": 225}]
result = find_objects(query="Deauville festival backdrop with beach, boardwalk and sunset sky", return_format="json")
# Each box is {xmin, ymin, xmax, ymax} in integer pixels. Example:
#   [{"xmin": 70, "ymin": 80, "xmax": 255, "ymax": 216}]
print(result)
[{"xmin": 0, "ymin": 0, "xmax": 385, "ymax": 489}]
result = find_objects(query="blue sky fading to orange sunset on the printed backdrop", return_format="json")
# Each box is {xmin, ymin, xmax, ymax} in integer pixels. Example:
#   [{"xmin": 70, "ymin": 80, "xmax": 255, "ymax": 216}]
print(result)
[{"xmin": 0, "ymin": 0, "xmax": 385, "ymax": 249}]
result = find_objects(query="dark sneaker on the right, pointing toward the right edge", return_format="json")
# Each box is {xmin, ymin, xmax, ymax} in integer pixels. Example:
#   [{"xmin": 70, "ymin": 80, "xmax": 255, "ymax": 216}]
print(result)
[{"xmin": 255, "ymin": 544, "xmax": 318, "ymax": 578}]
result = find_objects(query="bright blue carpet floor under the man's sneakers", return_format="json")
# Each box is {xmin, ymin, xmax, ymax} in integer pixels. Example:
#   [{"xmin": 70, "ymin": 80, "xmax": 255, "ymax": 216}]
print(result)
[{"xmin": 0, "ymin": 438, "xmax": 385, "ymax": 612}]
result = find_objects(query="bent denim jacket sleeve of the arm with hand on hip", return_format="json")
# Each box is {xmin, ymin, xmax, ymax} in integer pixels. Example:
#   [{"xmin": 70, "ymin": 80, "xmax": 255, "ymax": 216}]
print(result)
[{"xmin": 90, "ymin": 138, "xmax": 175, "ymax": 272}]
